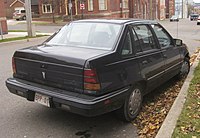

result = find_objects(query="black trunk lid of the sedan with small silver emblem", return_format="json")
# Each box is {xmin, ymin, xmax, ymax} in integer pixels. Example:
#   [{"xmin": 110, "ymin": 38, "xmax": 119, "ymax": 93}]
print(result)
[{"xmin": 14, "ymin": 45, "xmax": 108, "ymax": 93}]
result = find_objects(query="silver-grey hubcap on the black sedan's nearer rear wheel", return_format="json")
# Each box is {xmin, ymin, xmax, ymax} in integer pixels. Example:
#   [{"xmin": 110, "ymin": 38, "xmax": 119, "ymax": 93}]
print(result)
[{"xmin": 129, "ymin": 89, "xmax": 142, "ymax": 116}]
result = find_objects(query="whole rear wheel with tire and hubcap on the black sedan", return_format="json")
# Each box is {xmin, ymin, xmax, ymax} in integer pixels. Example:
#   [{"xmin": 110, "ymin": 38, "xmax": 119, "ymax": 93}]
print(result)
[{"xmin": 116, "ymin": 86, "xmax": 143, "ymax": 122}]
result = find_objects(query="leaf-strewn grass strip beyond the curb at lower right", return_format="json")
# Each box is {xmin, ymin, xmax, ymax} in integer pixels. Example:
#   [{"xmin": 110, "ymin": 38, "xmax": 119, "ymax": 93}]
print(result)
[{"xmin": 172, "ymin": 63, "xmax": 200, "ymax": 138}]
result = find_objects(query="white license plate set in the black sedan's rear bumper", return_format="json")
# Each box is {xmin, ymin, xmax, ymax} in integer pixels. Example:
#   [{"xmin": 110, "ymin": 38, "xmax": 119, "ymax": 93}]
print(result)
[{"xmin": 34, "ymin": 93, "xmax": 50, "ymax": 107}]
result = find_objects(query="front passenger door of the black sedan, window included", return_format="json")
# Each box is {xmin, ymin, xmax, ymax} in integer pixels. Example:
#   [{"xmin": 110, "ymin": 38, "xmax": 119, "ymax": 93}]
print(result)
[{"xmin": 152, "ymin": 24, "xmax": 182, "ymax": 79}]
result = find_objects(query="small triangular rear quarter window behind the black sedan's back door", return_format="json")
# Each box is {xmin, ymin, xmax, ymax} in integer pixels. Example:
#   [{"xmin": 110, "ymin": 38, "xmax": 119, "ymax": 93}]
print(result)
[{"xmin": 121, "ymin": 31, "xmax": 133, "ymax": 55}]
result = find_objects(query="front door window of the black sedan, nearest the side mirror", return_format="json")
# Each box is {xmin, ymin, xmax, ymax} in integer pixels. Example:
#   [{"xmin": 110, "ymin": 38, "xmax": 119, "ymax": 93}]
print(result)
[{"xmin": 151, "ymin": 25, "xmax": 172, "ymax": 47}]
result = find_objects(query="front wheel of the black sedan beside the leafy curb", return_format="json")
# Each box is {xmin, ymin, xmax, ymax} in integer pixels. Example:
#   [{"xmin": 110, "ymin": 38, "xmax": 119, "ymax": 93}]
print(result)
[{"xmin": 178, "ymin": 57, "xmax": 190, "ymax": 79}]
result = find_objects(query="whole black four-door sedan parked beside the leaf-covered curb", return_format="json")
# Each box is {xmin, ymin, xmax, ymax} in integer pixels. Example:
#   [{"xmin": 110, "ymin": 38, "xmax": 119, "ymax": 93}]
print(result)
[{"xmin": 6, "ymin": 19, "xmax": 190, "ymax": 121}]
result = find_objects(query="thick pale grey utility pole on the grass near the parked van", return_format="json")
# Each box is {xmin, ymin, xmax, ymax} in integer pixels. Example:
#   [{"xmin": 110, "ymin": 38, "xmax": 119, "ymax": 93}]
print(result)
[{"xmin": 25, "ymin": 0, "xmax": 33, "ymax": 37}]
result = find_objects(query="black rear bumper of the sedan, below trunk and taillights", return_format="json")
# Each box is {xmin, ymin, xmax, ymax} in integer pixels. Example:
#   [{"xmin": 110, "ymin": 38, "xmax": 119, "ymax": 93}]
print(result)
[{"xmin": 6, "ymin": 78, "xmax": 129, "ymax": 116}]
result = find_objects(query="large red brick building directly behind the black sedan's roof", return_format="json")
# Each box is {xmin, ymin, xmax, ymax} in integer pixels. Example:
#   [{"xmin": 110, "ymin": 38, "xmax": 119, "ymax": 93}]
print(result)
[{"xmin": 73, "ymin": 0, "xmax": 159, "ymax": 19}]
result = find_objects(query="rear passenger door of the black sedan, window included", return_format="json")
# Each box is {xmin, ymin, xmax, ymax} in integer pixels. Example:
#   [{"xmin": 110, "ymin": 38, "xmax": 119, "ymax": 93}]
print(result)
[{"xmin": 132, "ymin": 25, "xmax": 164, "ymax": 90}]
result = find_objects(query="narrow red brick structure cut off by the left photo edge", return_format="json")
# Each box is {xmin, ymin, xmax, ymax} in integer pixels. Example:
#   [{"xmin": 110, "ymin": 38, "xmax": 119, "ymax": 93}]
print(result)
[{"xmin": 0, "ymin": 0, "xmax": 8, "ymax": 34}]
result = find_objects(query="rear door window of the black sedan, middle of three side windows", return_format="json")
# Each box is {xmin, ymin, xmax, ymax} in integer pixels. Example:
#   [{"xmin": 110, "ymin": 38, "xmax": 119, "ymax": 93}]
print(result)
[{"xmin": 133, "ymin": 25, "xmax": 157, "ymax": 51}]
